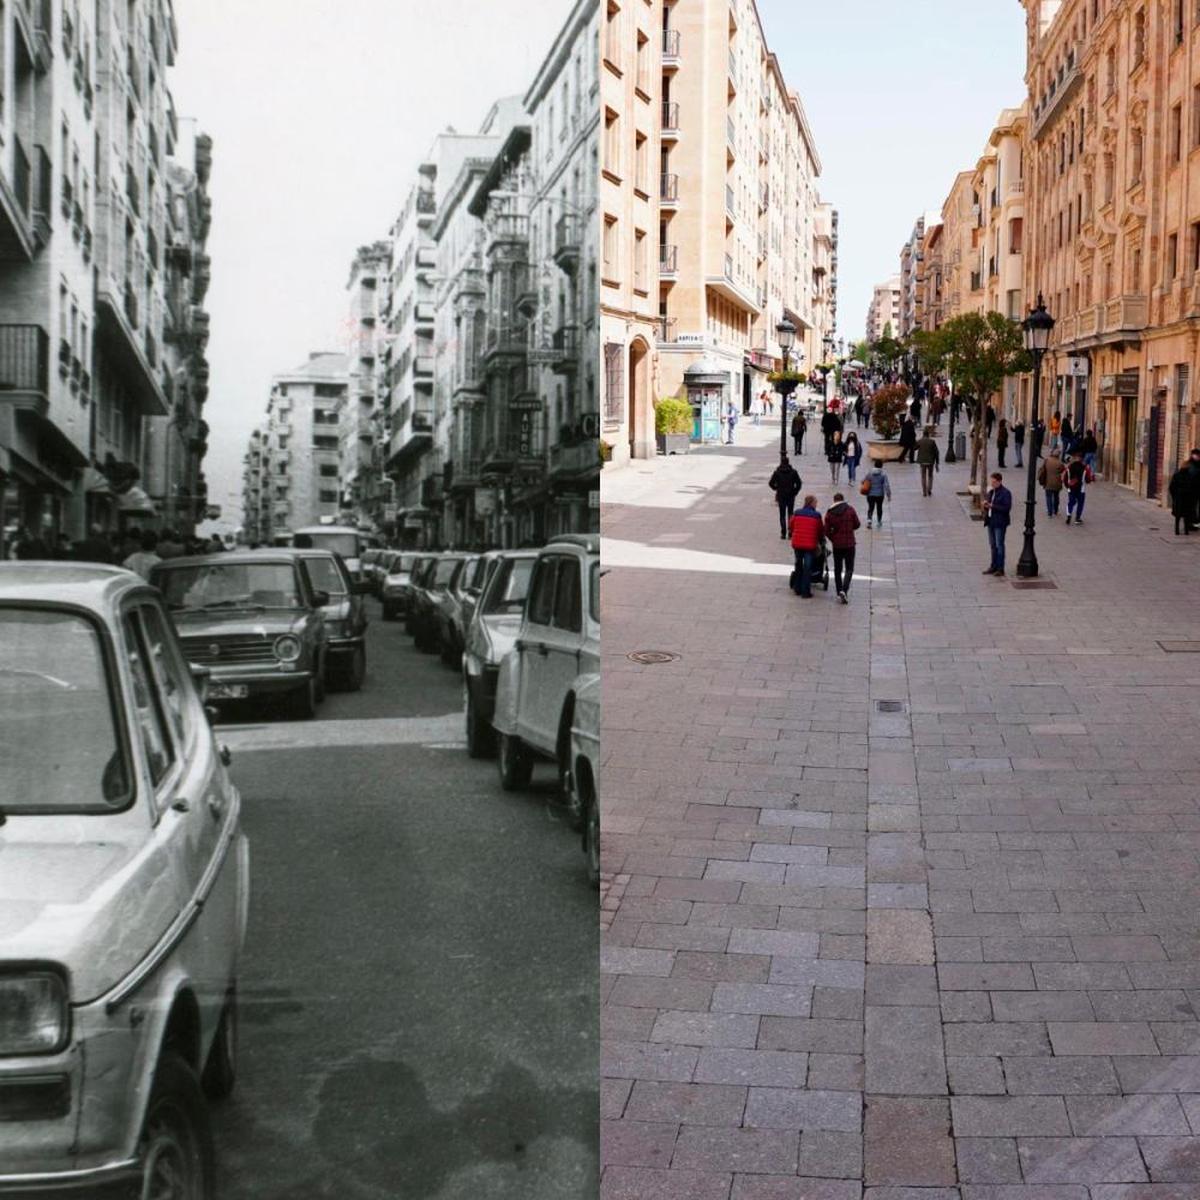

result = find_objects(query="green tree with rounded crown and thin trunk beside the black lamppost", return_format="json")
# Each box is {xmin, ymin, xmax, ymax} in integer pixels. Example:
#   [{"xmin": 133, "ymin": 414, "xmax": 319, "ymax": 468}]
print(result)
[{"xmin": 931, "ymin": 312, "xmax": 1031, "ymax": 504}]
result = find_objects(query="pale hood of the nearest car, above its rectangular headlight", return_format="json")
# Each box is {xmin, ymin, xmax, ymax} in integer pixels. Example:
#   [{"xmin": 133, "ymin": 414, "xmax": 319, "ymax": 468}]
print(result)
[{"xmin": 0, "ymin": 816, "xmax": 180, "ymax": 1003}]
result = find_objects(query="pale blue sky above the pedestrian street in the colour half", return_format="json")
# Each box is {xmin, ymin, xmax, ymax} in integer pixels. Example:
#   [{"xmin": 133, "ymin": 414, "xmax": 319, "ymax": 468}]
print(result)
[{"xmin": 758, "ymin": 0, "xmax": 1025, "ymax": 341}]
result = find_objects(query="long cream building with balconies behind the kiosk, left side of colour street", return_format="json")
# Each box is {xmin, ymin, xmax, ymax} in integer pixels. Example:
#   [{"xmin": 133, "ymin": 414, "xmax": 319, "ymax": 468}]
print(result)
[{"xmin": 643, "ymin": 0, "xmax": 824, "ymax": 438}]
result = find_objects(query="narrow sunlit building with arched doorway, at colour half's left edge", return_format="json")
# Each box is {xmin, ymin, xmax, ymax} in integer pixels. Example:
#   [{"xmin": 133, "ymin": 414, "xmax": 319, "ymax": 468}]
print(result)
[{"xmin": 595, "ymin": 0, "xmax": 662, "ymax": 466}]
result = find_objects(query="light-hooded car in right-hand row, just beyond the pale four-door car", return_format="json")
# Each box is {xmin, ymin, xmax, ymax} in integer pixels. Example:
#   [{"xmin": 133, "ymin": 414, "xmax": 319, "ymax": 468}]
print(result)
[{"xmin": 462, "ymin": 550, "xmax": 538, "ymax": 758}]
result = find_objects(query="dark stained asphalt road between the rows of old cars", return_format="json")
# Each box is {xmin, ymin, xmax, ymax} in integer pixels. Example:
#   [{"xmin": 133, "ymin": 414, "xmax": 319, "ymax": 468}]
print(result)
[{"xmin": 216, "ymin": 601, "xmax": 599, "ymax": 1200}]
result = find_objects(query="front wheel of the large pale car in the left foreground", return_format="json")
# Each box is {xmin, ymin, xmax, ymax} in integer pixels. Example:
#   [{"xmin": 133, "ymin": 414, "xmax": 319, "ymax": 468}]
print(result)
[{"xmin": 138, "ymin": 1050, "xmax": 215, "ymax": 1200}]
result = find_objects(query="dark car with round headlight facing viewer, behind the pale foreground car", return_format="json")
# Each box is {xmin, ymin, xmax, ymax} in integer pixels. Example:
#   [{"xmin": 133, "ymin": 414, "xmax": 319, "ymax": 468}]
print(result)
[{"xmin": 150, "ymin": 550, "xmax": 334, "ymax": 719}]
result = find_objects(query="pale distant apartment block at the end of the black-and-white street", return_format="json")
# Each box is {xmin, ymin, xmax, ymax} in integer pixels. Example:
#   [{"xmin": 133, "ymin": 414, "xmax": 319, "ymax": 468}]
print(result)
[{"xmin": 242, "ymin": 352, "xmax": 354, "ymax": 544}]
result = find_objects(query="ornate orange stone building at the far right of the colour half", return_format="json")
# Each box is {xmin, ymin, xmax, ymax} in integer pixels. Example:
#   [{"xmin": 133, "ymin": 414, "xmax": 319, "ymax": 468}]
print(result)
[{"xmin": 1025, "ymin": 0, "xmax": 1200, "ymax": 499}]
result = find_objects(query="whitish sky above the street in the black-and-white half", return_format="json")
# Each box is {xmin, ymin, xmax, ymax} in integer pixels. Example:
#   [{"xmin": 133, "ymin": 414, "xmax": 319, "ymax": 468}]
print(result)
[{"xmin": 168, "ymin": 0, "xmax": 571, "ymax": 520}]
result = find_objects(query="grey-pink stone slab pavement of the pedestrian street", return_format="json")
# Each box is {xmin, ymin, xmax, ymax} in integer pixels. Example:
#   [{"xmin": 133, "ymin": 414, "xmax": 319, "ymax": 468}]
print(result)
[{"xmin": 601, "ymin": 415, "xmax": 1200, "ymax": 1200}]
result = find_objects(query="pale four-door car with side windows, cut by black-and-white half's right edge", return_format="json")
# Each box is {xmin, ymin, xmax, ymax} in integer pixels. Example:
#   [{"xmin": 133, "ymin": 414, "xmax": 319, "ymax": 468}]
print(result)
[{"xmin": 492, "ymin": 534, "xmax": 600, "ymax": 822}]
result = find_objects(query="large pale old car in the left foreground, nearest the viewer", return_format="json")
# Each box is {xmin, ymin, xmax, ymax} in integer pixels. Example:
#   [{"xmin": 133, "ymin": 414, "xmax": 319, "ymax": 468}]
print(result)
[{"xmin": 0, "ymin": 563, "xmax": 250, "ymax": 1200}]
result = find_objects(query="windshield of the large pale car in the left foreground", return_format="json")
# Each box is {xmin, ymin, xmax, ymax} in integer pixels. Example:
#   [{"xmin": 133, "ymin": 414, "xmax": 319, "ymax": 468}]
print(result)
[{"xmin": 0, "ymin": 607, "xmax": 131, "ymax": 815}]
